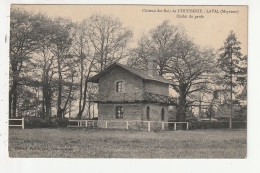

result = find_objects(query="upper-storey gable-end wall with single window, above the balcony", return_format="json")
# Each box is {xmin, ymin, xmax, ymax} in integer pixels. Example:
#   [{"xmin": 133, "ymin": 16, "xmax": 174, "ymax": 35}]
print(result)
[{"xmin": 99, "ymin": 67, "xmax": 144, "ymax": 101}]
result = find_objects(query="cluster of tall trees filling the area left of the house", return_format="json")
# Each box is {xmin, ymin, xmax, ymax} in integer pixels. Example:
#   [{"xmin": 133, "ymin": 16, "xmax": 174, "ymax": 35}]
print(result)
[{"xmin": 9, "ymin": 8, "xmax": 132, "ymax": 119}]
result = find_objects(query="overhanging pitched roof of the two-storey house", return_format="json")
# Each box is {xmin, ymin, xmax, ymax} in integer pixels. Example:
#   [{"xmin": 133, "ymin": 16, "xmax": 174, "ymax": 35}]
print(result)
[{"xmin": 89, "ymin": 63, "xmax": 173, "ymax": 84}]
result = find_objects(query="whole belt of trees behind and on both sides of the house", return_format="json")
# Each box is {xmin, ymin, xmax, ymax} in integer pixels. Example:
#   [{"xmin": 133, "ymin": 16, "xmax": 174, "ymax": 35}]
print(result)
[{"xmin": 9, "ymin": 8, "xmax": 247, "ymax": 121}]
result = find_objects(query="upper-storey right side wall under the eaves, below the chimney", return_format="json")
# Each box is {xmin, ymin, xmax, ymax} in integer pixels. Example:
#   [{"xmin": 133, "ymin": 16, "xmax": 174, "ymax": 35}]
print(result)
[{"xmin": 144, "ymin": 80, "xmax": 169, "ymax": 96}]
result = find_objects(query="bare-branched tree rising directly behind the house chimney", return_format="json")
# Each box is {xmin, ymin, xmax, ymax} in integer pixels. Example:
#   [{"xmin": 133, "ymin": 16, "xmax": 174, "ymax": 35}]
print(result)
[{"xmin": 128, "ymin": 21, "xmax": 177, "ymax": 76}]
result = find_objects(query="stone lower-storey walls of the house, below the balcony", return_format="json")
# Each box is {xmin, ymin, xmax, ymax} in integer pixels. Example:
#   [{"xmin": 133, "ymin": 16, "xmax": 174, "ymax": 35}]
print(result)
[{"xmin": 98, "ymin": 103, "xmax": 168, "ymax": 130}]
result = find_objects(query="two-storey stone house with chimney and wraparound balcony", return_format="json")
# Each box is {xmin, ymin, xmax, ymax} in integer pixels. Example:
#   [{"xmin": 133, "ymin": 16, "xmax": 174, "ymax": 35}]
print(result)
[{"xmin": 90, "ymin": 61, "xmax": 176, "ymax": 128}]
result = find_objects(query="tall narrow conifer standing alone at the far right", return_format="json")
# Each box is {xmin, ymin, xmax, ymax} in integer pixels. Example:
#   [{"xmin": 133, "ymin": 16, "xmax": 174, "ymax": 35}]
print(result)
[{"xmin": 218, "ymin": 31, "xmax": 247, "ymax": 128}]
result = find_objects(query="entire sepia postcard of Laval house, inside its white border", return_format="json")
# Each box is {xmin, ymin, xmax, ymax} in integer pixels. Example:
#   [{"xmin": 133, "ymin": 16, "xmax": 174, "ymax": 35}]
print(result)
[{"xmin": 6, "ymin": 4, "xmax": 248, "ymax": 159}]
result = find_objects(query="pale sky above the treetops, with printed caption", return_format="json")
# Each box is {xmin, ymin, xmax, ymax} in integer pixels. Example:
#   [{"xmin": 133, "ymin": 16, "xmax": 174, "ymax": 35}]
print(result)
[{"xmin": 11, "ymin": 5, "xmax": 248, "ymax": 54}]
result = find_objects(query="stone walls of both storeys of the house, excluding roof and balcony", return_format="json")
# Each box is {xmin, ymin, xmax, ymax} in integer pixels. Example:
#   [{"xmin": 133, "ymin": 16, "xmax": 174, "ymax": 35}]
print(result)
[{"xmin": 98, "ymin": 67, "xmax": 172, "ymax": 130}]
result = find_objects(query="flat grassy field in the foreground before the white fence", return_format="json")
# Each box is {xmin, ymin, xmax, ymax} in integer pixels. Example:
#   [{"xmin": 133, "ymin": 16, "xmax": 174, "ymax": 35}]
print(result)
[{"xmin": 9, "ymin": 128, "xmax": 246, "ymax": 158}]
